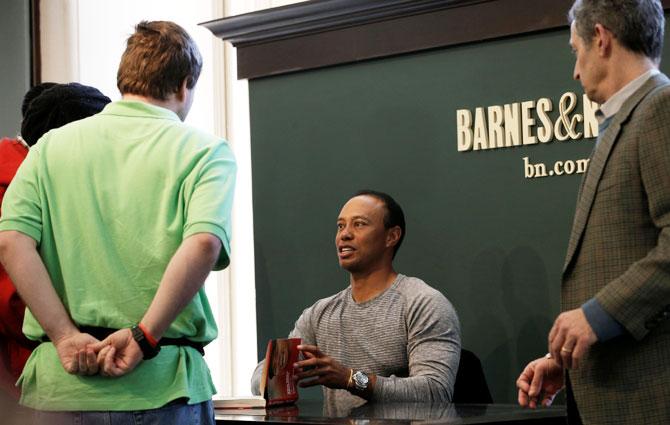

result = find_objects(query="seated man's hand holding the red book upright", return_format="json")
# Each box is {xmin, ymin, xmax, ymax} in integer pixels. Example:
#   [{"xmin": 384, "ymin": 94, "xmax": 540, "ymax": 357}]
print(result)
[{"xmin": 294, "ymin": 345, "xmax": 351, "ymax": 389}]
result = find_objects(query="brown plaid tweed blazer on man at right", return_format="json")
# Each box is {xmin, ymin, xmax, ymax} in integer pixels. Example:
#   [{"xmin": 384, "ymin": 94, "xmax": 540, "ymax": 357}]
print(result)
[{"xmin": 561, "ymin": 74, "xmax": 670, "ymax": 425}]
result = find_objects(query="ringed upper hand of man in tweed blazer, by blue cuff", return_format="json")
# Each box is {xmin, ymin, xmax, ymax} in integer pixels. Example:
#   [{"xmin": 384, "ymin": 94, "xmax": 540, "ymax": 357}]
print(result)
[{"xmin": 549, "ymin": 308, "xmax": 598, "ymax": 369}]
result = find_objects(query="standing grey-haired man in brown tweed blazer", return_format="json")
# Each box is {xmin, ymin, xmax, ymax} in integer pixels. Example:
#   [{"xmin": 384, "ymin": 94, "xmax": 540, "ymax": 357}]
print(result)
[{"xmin": 517, "ymin": 0, "xmax": 670, "ymax": 425}]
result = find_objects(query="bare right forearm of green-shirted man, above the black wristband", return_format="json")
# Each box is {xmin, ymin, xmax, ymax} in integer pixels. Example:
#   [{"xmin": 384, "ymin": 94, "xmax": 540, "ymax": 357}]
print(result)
[{"xmin": 141, "ymin": 233, "xmax": 221, "ymax": 339}]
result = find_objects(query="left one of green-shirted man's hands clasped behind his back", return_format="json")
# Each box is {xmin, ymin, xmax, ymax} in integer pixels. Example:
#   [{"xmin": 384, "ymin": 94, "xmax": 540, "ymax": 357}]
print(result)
[{"xmin": 53, "ymin": 332, "xmax": 100, "ymax": 375}]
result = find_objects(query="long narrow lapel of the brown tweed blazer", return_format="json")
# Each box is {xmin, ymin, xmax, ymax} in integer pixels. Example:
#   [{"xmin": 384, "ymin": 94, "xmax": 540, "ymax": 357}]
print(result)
[{"xmin": 563, "ymin": 74, "xmax": 670, "ymax": 273}]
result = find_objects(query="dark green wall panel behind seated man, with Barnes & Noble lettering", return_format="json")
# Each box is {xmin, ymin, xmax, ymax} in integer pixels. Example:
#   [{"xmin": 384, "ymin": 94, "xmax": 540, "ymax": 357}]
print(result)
[{"xmin": 250, "ymin": 26, "xmax": 670, "ymax": 403}]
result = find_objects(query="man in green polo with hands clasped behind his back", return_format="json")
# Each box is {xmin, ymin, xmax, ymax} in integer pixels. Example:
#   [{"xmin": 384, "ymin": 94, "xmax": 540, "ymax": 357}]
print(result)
[{"xmin": 0, "ymin": 22, "xmax": 236, "ymax": 424}]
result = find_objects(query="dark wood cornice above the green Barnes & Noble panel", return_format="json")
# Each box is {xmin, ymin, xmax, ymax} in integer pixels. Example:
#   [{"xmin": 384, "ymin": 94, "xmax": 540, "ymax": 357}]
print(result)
[{"xmin": 202, "ymin": 0, "xmax": 670, "ymax": 78}]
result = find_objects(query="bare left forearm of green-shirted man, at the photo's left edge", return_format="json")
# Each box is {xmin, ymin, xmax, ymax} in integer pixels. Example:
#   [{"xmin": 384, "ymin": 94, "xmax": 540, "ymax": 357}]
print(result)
[{"xmin": 0, "ymin": 231, "xmax": 79, "ymax": 341}]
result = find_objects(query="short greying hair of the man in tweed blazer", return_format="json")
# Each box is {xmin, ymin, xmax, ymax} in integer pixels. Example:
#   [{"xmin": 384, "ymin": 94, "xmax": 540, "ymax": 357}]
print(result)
[{"xmin": 568, "ymin": 0, "xmax": 665, "ymax": 61}]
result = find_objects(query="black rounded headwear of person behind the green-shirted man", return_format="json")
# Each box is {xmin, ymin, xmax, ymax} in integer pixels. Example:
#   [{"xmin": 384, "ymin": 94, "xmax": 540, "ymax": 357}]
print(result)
[{"xmin": 21, "ymin": 83, "xmax": 111, "ymax": 146}]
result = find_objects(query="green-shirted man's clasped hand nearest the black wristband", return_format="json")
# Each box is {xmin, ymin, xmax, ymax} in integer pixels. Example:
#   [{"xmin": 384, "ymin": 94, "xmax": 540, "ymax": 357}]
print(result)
[{"xmin": 90, "ymin": 329, "xmax": 143, "ymax": 377}]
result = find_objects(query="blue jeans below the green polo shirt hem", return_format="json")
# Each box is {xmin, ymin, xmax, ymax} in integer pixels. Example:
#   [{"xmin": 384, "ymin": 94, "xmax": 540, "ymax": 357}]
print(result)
[{"xmin": 34, "ymin": 400, "xmax": 215, "ymax": 425}]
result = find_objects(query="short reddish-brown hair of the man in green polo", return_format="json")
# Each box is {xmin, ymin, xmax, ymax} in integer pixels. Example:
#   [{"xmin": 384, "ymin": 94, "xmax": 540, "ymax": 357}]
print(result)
[{"xmin": 116, "ymin": 21, "xmax": 202, "ymax": 100}]
